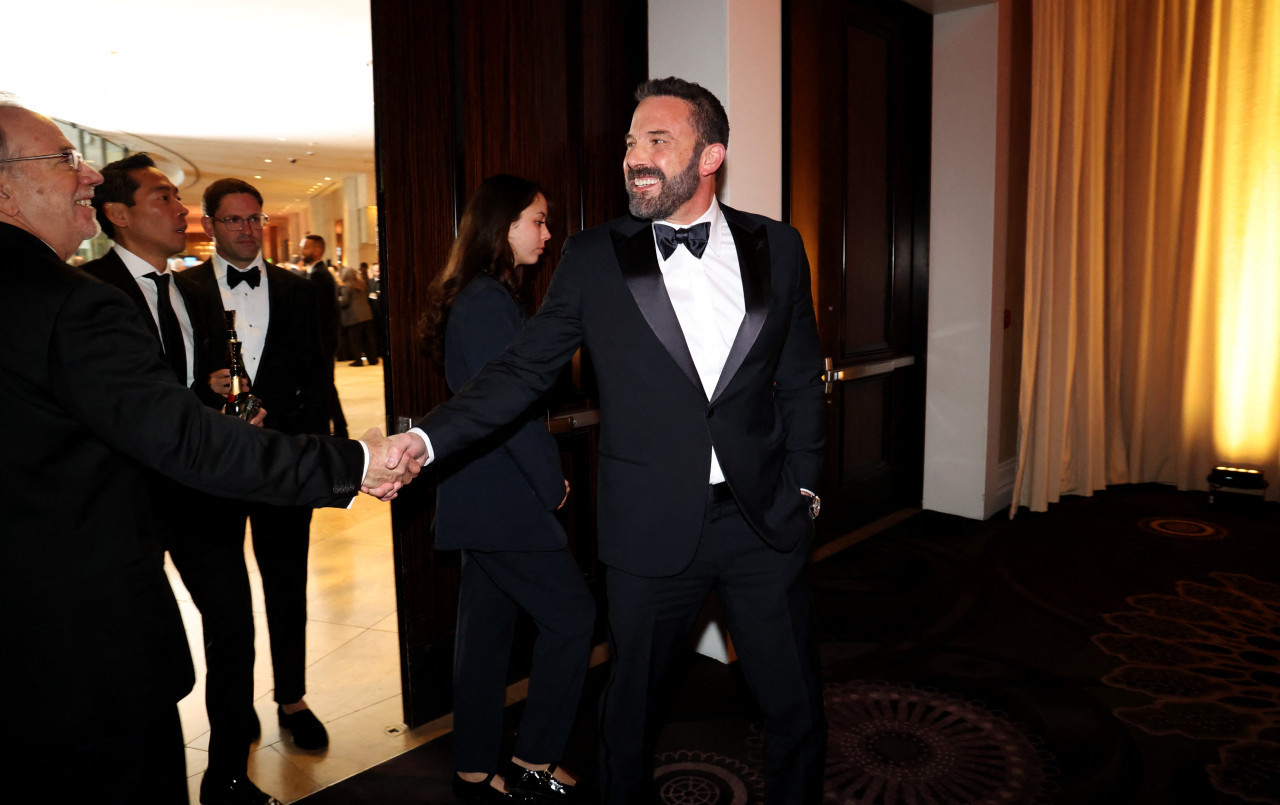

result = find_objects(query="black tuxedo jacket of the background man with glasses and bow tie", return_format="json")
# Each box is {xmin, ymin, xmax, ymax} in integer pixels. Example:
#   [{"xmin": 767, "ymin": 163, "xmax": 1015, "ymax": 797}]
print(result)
[{"xmin": 186, "ymin": 260, "xmax": 329, "ymax": 434}]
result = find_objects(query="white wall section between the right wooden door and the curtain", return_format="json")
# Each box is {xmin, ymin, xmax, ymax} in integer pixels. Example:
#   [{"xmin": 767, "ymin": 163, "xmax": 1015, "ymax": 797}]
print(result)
[{"xmin": 924, "ymin": 4, "xmax": 1009, "ymax": 520}]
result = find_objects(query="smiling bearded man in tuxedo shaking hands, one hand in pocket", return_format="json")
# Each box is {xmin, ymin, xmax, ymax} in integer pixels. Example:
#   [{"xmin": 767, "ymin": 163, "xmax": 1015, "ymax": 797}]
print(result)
[{"xmin": 392, "ymin": 78, "xmax": 826, "ymax": 805}]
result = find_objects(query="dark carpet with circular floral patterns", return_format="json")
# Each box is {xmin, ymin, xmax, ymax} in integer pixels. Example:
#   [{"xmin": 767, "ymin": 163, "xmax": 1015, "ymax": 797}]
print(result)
[{"xmin": 303, "ymin": 485, "xmax": 1280, "ymax": 805}]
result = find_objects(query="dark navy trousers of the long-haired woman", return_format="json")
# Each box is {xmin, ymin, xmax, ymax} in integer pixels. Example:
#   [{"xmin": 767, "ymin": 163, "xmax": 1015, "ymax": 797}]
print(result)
[{"xmin": 453, "ymin": 548, "xmax": 595, "ymax": 774}]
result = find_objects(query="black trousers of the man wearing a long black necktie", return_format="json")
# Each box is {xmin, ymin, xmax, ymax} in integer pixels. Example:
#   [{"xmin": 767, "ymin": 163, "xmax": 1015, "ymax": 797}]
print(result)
[{"xmin": 166, "ymin": 514, "xmax": 253, "ymax": 778}]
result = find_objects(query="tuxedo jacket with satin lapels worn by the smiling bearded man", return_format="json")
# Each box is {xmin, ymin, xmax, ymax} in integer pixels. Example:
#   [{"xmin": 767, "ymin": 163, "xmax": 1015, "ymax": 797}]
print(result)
[{"xmin": 417, "ymin": 205, "xmax": 823, "ymax": 576}]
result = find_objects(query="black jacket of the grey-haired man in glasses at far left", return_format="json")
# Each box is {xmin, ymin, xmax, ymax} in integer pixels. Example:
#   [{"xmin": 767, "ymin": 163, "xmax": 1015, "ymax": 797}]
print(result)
[{"xmin": 0, "ymin": 224, "xmax": 364, "ymax": 744}]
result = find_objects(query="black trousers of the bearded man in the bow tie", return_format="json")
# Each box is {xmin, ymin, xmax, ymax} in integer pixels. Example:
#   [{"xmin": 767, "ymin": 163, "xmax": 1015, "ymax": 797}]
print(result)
[{"xmin": 600, "ymin": 491, "xmax": 827, "ymax": 805}]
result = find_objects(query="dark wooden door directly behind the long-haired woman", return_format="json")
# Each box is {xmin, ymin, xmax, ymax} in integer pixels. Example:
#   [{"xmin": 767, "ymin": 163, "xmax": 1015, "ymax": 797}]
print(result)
[{"xmin": 371, "ymin": 0, "xmax": 648, "ymax": 726}]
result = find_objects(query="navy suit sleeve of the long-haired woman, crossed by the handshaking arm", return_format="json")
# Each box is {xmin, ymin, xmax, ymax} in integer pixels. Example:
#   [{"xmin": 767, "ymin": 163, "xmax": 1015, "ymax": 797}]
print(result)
[{"xmin": 445, "ymin": 284, "xmax": 564, "ymax": 509}]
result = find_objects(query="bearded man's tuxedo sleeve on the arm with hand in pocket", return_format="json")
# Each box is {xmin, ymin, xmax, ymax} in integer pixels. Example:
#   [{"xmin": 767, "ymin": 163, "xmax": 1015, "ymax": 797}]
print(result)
[{"xmin": 773, "ymin": 230, "xmax": 823, "ymax": 491}]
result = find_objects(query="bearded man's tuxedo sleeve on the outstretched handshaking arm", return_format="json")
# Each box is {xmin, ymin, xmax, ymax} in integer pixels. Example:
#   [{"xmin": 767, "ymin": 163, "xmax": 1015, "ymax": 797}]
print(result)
[{"xmin": 413, "ymin": 238, "xmax": 589, "ymax": 456}]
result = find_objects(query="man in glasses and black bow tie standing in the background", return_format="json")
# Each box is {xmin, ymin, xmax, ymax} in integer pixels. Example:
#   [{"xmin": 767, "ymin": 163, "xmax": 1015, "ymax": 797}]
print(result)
[{"xmin": 187, "ymin": 179, "xmax": 329, "ymax": 749}]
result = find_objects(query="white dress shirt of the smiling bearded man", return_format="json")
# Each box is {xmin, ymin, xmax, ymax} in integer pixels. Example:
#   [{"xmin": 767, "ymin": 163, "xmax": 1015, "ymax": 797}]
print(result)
[{"xmin": 653, "ymin": 198, "xmax": 746, "ymax": 484}]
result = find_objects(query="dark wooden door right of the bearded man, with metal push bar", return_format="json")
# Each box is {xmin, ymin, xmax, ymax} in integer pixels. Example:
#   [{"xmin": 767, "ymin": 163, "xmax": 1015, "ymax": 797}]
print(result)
[{"xmin": 786, "ymin": 0, "xmax": 932, "ymax": 538}]
